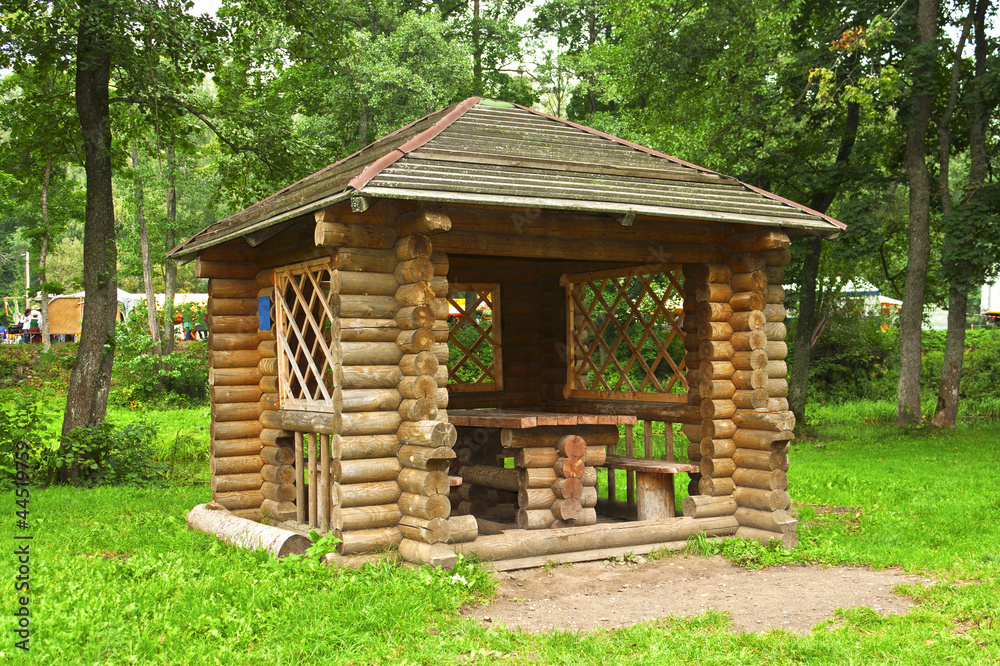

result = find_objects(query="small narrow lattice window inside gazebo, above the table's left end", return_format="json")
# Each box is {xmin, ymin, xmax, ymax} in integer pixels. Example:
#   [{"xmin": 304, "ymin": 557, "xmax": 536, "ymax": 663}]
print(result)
[{"xmin": 448, "ymin": 284, "xmax": 503, "ymax": 391}]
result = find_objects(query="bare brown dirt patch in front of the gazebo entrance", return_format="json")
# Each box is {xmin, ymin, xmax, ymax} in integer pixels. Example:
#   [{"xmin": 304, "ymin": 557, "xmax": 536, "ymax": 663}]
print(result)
[{"xmin": 463, "ymin": 556, "xmax": 932, "ymax": 633}]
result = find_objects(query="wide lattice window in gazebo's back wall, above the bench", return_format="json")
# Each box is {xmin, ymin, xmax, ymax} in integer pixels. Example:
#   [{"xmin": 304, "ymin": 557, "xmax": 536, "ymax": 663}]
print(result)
[{"xmin": 561, "ymin": 266, "xmax": 687, "ymax": 402}]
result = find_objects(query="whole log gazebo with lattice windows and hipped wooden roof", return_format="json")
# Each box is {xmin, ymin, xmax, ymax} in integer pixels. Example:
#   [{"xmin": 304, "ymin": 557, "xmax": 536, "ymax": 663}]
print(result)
[{"xmin": 170, "ymin": 98, "xmax": 844, "ymax": 566}]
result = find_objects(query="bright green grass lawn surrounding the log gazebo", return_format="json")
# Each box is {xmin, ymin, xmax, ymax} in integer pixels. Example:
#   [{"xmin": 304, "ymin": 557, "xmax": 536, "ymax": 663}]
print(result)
[{"xmin": 0, "ymin": 410, "xmax": 1000, "ymax": 665}]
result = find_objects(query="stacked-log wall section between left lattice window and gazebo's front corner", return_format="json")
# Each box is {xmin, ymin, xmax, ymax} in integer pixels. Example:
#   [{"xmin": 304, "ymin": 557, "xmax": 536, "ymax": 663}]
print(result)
[{"xmin": 324, "ymin": 239, "xmax": 403, "ymax": 555}]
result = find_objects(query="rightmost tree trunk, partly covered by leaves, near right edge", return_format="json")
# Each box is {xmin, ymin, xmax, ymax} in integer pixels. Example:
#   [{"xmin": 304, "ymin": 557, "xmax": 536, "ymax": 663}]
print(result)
[{"xmin": 931, "ymin": 11, "xmax": 975, "ymax": 428}]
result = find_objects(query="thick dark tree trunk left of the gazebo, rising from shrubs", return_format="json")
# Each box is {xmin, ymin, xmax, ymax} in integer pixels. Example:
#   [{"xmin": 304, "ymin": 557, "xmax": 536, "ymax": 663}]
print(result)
[{"xmin": 62, "ymin": 3, "xmax": 118, "ymax": 481}]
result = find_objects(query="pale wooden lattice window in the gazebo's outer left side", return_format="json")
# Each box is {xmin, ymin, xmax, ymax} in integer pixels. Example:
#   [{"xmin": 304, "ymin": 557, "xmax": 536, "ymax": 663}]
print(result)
[{"xmin": 274, "ymin": 259, "xmax": 339, "ymax": 412}]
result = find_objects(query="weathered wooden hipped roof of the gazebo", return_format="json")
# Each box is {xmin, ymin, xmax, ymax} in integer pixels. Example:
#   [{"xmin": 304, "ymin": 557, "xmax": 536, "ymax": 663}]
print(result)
[{"xmin": 170, "ymin": 97, "xmax": 845, "ymax": 258}]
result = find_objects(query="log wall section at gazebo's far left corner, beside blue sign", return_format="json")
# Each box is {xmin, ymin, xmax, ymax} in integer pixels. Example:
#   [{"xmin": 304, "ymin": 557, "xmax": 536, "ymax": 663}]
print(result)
[{"xmin": 204, "ymin": 241, "xmax": 265, "ymax": 518}]
